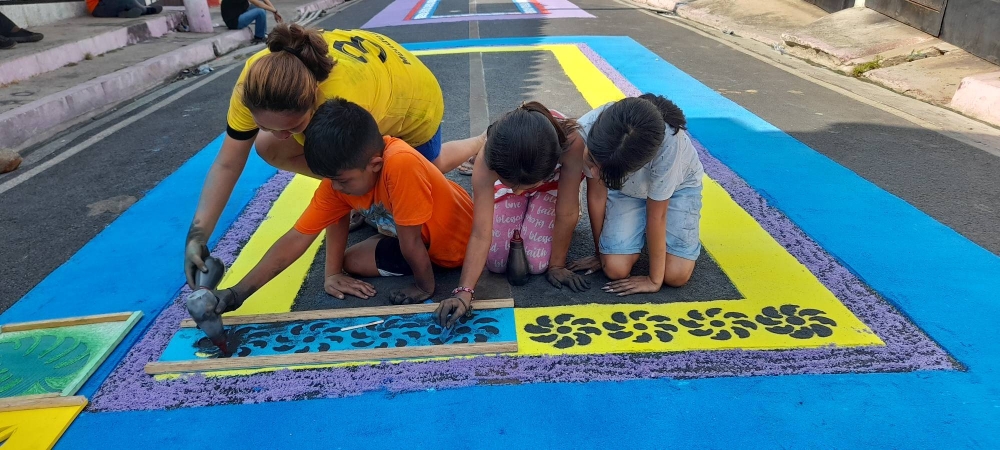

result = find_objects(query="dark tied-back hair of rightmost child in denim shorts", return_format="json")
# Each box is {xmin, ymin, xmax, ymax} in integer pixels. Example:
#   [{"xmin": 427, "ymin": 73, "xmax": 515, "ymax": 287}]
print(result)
[{"xmin": 587, "ymin": 94, "xmax": 687, "ymax": 190}]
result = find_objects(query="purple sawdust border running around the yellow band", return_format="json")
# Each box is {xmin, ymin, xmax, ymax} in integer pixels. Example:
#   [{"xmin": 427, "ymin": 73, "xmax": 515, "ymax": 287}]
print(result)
[{"xmin": 90, "ymin": 50, "xmax": 956, "ymax": 411}]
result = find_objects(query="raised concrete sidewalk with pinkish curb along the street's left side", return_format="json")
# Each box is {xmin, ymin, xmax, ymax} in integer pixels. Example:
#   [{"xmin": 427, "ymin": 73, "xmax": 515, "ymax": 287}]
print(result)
[{"xmin": 0, "ymin": 0, "xmax": 344, "ymax": 158}]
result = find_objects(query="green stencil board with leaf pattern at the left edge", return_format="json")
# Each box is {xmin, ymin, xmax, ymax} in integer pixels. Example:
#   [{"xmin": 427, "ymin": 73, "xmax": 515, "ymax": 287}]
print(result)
[{"xmin": 0, "ymin": 312, "xmax": 142, "ymax": 398}]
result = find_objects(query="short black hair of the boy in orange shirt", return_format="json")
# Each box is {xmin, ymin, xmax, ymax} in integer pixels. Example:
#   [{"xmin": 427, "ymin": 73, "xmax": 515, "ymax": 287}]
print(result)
[{"xmin": 304, "ymin": 98, "xmax": 385, "ymax": 178}]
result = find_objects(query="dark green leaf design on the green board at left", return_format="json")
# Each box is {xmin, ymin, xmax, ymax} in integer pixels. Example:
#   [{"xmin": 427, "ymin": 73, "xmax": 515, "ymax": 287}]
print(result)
[{"xmin": 0, "ymin": 334, "xmax": 91, "ymax": 397}]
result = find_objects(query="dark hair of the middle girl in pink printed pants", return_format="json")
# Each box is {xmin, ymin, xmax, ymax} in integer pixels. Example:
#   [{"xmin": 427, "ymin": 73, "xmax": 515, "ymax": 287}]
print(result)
[{"xmin": 484, "ymin": 102, "xmax": 579, "ymax": 187}]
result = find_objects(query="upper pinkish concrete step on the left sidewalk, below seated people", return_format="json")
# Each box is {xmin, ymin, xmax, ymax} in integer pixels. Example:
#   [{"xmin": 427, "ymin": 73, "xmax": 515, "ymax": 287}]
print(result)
[{"xmin": 0, "ymin": 11, "xmax": 184, "ymax": 85}]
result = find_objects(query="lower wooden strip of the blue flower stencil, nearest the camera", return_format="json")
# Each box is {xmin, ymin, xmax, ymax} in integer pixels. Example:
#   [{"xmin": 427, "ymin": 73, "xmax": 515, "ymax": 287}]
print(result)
[{"xmin": 146, "ymin": 342, "xmax": 517, "ymax": 375}]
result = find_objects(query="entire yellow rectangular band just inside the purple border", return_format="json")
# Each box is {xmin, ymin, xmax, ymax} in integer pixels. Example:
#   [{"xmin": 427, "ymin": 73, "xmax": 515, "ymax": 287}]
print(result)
[{"xmin": 156, "ymin": 44, "xmax": 885, "ymax": 380}]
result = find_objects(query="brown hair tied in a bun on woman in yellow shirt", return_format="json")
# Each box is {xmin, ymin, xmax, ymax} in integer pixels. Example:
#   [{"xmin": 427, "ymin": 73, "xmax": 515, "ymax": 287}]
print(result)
[{"xmin": 242, "ymin": 24, "xmax": 334, "ymax": 113}]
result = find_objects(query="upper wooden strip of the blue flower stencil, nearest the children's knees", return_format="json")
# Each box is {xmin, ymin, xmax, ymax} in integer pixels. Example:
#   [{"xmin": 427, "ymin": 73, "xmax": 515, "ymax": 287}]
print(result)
[{"xmin": 181, "ymin": 298, "xmax": 514, "ymax": 328}]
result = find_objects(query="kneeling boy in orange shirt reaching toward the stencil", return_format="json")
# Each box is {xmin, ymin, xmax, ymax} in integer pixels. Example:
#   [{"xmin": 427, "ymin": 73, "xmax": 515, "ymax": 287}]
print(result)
[{"xmin": 201, "ymin": 98, "xmax": 472, "ymax": 314}]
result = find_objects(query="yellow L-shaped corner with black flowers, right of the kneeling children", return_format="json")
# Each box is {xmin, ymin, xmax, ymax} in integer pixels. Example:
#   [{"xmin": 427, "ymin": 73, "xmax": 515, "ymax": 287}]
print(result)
[{"xmin": 514, "ymin": 177, "xmax": 885, "ymax": 355}]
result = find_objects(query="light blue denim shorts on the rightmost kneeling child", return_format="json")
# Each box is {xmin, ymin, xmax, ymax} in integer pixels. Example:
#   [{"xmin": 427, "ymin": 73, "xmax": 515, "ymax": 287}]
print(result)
[{"xmin": 601, "ymin": 186, "xmax": 702, "ymax": 261}]
